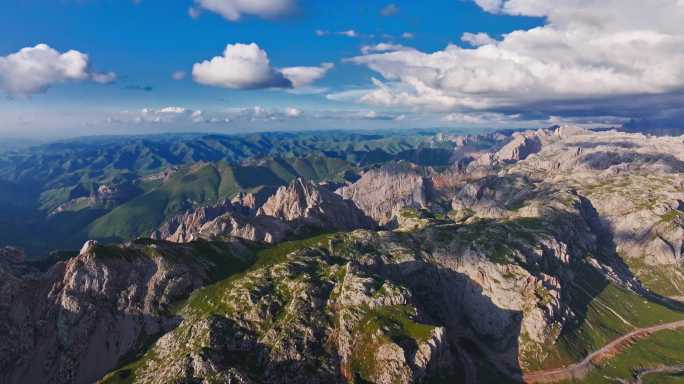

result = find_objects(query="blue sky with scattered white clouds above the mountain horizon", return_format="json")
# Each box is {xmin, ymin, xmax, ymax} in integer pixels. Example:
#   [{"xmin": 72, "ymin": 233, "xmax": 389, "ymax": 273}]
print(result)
[{"xmin": 0, "ymin": 0, "xmax": 681, "ymax": 137}]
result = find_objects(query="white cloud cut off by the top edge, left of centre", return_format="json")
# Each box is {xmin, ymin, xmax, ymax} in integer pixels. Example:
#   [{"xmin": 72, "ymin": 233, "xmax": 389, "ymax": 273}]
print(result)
[{"xmin": 189, "ymin": 0, "xmax": 296, "ymax": 21}]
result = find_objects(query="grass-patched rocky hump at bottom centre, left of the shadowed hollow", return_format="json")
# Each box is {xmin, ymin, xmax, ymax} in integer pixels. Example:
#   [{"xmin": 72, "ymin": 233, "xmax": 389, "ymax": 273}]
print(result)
[{"xmin": 104, "ymin": 231, "xmax": 455, "ymax": 384}]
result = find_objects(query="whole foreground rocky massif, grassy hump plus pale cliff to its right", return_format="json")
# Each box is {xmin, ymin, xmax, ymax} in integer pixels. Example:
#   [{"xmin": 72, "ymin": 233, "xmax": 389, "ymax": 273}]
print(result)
[{"xmin": 97, "ymin": 185, "xmax": 632, "ymax": 383}]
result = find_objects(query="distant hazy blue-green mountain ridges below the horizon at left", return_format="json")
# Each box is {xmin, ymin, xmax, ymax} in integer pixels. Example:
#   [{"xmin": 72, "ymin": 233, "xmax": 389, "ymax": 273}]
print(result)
[{"xmin": 0, "ymin": 131, "xmax": 464, "ymax": 256}]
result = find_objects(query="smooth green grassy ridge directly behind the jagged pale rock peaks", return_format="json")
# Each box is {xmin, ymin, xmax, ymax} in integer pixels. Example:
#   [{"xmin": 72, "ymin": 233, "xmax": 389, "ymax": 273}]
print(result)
[{"xmin": 84, "ymin": 156, "xmax": 353, "ymax": 241}]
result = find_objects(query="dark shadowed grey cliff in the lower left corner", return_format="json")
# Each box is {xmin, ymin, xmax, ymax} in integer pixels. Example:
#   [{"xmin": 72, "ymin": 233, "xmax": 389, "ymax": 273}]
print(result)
[{"xmin": 0, "ymin": 241, "xmax": 248, "ymax": 383}]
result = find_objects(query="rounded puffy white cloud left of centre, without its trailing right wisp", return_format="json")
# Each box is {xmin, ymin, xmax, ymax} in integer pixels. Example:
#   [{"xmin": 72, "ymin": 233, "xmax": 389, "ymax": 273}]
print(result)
[{"xmin": 192, "ymin": 43, "xmax": 292, "ymax": 89}]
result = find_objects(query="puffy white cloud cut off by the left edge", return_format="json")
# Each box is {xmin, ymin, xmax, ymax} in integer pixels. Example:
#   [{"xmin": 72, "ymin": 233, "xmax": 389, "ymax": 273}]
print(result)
[{"xmin": 0, "ymin": 44, "xmax": 91, "ymax": 96}]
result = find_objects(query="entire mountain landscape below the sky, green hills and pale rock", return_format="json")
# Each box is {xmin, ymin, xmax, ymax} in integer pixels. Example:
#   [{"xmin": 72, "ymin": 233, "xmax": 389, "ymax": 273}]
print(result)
[{"xmin": 0, "ymin": 126, "xmax": 684, "ymax": 384}]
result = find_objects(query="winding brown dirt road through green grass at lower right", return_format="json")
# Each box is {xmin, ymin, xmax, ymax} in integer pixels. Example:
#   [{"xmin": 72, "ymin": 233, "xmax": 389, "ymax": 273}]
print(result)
[{"xmin": 522, "ymin": 320, "xmax": 684, "ymax": 383}]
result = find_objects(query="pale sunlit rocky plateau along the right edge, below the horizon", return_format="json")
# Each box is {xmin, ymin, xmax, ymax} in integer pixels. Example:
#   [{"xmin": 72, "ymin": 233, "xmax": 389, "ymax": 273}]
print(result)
[{"xmin": 507, "ymin": 127, "xmax": 684, "ymax": 297}]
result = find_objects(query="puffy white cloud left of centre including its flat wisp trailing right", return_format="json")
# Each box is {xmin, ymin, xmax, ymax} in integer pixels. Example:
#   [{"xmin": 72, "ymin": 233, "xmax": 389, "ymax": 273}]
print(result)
[{"xmin": 192, "ymin": 43, "xmax": 333, "ymax": 89}]
